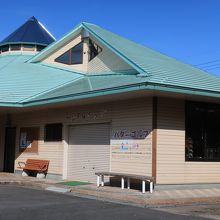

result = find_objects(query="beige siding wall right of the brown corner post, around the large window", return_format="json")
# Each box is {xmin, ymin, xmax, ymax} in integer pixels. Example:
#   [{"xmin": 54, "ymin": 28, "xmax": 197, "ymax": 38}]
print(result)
[{"xmin": 157, "ymin": 98, "xmax": 220, "ymax": 184}]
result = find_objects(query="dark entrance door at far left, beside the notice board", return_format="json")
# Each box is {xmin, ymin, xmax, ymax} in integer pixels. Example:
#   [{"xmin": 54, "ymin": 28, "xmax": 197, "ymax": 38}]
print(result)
[{"xmin": 4, "ymin": 128, "xmax": 16, "ymax": 173}]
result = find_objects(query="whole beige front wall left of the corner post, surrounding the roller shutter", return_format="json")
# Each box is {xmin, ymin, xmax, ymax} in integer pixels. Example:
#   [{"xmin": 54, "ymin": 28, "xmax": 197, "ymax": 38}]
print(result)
[{"xmin": 12, "ymin": 98, "xmax": 152, "ymax": 179}]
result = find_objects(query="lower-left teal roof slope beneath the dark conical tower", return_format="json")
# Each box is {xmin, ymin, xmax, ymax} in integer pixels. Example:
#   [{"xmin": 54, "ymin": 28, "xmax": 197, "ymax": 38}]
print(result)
[{"xmin": 0, "ymin": 55, "xmax": 82, "ymax": 104}]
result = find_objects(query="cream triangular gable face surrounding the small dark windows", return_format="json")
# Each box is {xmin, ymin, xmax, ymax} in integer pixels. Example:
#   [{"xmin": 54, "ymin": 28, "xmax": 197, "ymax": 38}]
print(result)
[{"xmin": 31, "ymin": 25, "xmax": 134, "ymax": 73}]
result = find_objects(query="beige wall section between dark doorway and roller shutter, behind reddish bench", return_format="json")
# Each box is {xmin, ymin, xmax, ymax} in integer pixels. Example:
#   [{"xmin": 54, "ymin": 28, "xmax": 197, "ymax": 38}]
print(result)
[{"xmin": 12, "ymin": 111, "xmax": 63, "ymax": 174}]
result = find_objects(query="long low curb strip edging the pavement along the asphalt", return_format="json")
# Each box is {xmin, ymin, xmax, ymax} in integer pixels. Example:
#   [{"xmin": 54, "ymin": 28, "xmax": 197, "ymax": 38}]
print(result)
[{"xmin": 0, "ymin": 180, "xmax": 220, "ymax": 208}]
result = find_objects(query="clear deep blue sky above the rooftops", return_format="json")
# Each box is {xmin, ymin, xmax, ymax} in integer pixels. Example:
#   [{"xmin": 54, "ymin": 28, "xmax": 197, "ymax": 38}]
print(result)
[{"xmin": 0, "ymin": 0, "xmax": 220, "ymax": 75}]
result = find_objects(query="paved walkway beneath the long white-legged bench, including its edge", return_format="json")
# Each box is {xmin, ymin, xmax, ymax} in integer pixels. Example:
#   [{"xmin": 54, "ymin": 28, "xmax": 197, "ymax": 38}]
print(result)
[{"xmin": 71, "ymin": 184, "xmax": 220, "ymax": 207}]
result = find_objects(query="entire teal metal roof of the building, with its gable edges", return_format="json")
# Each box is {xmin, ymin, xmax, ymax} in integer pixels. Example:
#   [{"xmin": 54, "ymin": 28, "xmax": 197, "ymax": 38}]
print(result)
[{"xmin": 0, "ymin": 23, "xmax": 220, "ymax": 106}]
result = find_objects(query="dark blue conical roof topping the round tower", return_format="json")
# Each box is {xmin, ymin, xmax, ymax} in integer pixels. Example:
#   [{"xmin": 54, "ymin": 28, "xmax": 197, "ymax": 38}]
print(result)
[{"xmin": 0, "ymin": 17, "xmax": 55, "ymax": 46}]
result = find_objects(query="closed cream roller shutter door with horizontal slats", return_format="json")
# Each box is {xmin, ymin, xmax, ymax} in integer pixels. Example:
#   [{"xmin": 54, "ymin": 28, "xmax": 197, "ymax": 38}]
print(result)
[{"xmin": 67, "ymin": 123, "xmax": 110, "ymax": 183}]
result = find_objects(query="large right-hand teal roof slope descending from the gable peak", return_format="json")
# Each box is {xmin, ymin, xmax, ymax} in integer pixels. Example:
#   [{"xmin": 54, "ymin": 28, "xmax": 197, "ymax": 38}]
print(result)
[{"xmin": 81, "ymin": 23, "xmax": 220, "ymax": 92}]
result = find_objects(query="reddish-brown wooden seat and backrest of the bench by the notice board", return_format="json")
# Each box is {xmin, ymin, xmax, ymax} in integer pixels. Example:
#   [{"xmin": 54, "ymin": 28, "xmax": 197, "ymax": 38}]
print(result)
[{"xmin": 18, "ymin": 159, "xmax": 50, "ymax": 172}]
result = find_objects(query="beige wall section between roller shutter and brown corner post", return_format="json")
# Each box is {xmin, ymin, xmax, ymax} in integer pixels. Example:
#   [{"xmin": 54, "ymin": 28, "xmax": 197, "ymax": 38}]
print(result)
[{"xmin": 111, "ymin": 98, "xmax": 152, "ymax": 175}]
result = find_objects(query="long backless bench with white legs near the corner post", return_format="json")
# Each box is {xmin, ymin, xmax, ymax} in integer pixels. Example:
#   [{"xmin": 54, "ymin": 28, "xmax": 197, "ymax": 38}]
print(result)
[{"xmin": 95, "ymin": 172, "xmax": 154, "ymax": 193}]
